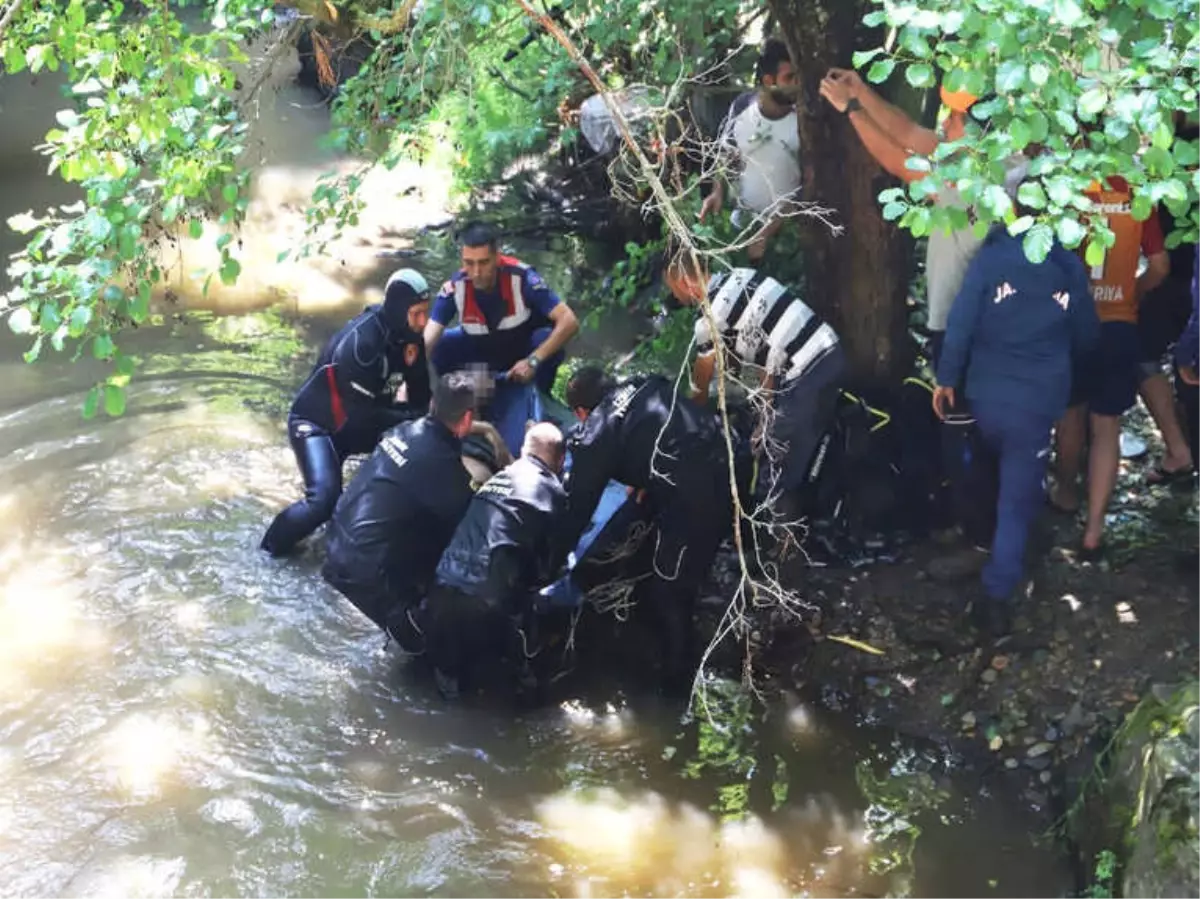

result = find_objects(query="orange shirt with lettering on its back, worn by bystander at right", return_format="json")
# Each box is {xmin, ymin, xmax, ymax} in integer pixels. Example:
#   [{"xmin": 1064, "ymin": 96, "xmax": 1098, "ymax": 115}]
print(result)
[{"xmin": 1080, "ymin": 179, "xmax": 1146, "ymax": 324}]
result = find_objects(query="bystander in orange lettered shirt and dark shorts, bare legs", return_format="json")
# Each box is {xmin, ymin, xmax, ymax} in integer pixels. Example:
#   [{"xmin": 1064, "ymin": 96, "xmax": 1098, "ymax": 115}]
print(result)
[{"xmin": 1050, "ymin": 176, "xmax": 1170, "ymax": 557}]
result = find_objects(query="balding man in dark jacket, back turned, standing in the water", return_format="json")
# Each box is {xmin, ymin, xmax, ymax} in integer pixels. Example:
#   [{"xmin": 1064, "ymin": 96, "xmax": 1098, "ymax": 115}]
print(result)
[{"xmin": 418, "ymin": 422, "xmax": 566, "ymax": 699}]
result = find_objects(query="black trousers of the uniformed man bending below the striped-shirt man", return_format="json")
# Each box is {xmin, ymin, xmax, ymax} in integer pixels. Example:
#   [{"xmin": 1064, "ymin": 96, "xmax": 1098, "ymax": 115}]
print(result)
[{"xmin": 637, "ymin": 456, "xmax": 732, "ymax": 689}]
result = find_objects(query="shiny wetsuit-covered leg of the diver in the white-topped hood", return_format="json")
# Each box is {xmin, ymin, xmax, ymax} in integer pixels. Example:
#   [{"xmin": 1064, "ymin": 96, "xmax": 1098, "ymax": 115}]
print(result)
[{"xmin": 260, "ymin": 418, "xmax": 344, "ymax": 556}]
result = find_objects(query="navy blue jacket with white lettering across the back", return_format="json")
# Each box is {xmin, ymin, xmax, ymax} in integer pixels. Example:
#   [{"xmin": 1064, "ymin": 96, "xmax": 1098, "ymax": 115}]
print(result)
[{"xmin": 937, "ymin": 226, "xmax": 1099, "ymax": 420}]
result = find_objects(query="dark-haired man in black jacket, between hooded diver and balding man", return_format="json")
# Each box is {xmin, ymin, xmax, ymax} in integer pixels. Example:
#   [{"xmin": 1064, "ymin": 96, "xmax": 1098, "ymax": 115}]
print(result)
[{"xmin": 322, "ymin": 372, "xmax": 475, "ymax": 648}]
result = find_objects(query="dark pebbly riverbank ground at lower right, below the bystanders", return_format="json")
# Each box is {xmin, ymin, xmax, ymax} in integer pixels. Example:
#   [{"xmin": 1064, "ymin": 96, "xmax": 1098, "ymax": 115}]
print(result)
[{"xmin": 761, "ymin": 432, "xmax": 1200, "ymax": 826}]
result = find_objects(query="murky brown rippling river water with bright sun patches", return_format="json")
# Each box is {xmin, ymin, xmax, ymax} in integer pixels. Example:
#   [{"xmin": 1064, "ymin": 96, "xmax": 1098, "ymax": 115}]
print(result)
[{"xmin": 0, "ymin": 59, "xmax": 1067, "ymax": 899}]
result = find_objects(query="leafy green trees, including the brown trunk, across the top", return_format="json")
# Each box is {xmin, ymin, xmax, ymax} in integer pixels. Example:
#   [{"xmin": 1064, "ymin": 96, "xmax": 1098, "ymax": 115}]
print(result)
[{"xmin": 0, "ymin": 0, "xmax": 1200, "ymax": 391}]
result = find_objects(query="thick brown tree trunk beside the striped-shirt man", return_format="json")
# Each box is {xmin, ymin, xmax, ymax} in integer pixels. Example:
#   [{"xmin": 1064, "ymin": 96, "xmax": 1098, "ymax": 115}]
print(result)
[{"xmin": 769, "ymin": 0, "xmax": 913, "ymax": 384}]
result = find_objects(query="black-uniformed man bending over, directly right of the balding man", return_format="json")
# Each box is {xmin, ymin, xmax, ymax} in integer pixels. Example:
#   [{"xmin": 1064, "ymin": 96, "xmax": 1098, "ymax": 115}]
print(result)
[{"xmin": 563, "ymin": 367, "xmax": 732, "ymax": 688}]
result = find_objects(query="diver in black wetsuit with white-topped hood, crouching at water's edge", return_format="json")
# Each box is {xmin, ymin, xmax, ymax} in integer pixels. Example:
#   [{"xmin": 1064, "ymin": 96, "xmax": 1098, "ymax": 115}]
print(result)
[{"xmin": 260, "ymin": 269, "xmax": 439, "ymax": 556}]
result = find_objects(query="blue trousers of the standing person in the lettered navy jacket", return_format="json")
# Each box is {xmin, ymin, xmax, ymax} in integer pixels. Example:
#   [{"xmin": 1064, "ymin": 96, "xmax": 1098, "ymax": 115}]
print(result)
[{"xmin": 974, "ymin": 403, "xmax": 1054, "ymax": 601}]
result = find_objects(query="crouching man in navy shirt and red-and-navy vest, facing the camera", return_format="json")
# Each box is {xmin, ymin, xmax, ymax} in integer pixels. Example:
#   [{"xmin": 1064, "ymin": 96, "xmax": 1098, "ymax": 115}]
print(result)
[{"xmin": 425, "ymin": 222, "xmax": 580, "ymax": 392}]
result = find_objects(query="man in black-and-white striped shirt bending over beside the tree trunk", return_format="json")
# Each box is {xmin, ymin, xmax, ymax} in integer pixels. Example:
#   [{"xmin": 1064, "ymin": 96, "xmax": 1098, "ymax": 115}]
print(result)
[{"xmin": 666, "ymin": 245, "xmax": 846, "ymax": 508}]
